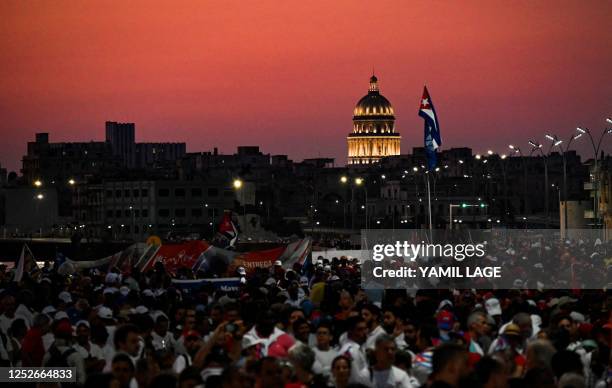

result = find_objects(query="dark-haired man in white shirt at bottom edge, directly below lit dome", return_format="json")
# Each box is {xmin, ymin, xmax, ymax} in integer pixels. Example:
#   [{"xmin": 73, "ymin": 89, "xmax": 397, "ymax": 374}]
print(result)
[{"xmin": 360, "ymin": 334, "xmax": 413, "ymax": 388}]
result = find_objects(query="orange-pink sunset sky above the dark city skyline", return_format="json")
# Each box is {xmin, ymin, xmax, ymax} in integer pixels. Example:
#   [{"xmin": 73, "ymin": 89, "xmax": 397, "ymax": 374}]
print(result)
[{"xmin": 0, "ymin": 0, "xmax": 612, "ymax": 170}]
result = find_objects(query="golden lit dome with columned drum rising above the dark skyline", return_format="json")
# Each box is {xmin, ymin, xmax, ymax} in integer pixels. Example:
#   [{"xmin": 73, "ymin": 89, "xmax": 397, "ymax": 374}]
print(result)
[{"xmin": 347, "ymin": 75, "xmax": 401, "ymax": 164}]
